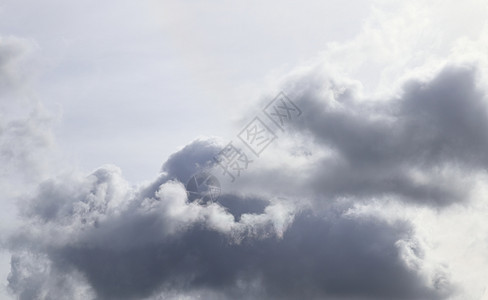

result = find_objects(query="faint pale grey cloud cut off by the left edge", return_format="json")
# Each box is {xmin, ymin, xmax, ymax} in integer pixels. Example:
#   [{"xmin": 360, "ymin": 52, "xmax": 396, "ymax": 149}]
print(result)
[{"xmin": 0, "ymin": 36, "xmax": 53, "ymax": 185}]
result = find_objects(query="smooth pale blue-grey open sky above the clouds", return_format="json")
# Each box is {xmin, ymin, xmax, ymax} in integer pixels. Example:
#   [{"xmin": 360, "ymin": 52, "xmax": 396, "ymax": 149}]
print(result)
[{"xmin": 0, "ymin": 1, "xmax": 370, "ymax": 182}]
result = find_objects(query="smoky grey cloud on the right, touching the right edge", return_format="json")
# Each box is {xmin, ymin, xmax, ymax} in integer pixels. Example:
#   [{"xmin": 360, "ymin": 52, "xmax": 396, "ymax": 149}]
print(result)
[{"xmin": 284, "ymin": 66, "xmax": 488, "ymax": 206}]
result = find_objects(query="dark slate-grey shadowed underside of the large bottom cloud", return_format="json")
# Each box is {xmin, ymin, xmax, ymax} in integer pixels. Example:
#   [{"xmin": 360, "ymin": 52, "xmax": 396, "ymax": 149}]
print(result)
[{"xmin": 49, "ymin": 214, "xmax": 441, "ymax": 299}]
